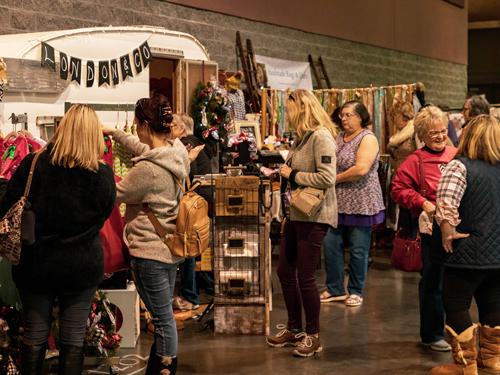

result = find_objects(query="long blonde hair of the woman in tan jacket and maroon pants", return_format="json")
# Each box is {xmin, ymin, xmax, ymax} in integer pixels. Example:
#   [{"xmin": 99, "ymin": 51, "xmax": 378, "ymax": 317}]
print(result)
[{"xmin": 287, "ymin": 89, "xmax": 337, "ymax": 140}]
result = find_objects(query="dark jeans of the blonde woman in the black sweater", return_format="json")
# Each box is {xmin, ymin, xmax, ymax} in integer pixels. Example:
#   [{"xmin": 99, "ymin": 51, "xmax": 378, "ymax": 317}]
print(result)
[{"xmin": 19, "ymin": 287, "xmax": 97, "ymax": 348}]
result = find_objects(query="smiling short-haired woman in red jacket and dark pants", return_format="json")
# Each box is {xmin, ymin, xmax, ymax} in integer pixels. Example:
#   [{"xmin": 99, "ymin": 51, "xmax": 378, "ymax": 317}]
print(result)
[{"xmin": 392, "ymin": 106, "xmax": 456, "ymax": 351}]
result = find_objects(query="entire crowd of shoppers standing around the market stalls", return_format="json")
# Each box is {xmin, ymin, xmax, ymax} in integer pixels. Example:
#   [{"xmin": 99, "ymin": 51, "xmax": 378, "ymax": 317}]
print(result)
[{"xmin": 0, "ymin": 89, "xmax": 500, "ymax": 375}]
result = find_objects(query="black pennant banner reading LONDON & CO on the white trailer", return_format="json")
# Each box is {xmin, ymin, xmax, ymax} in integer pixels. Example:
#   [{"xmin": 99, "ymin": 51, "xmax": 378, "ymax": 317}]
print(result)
[{"xmin": 41, "ymin": 41, "xmax": 152, "ymax": 87}]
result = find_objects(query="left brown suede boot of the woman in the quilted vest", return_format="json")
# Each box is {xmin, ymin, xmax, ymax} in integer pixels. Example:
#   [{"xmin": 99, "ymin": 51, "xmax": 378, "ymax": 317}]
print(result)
[{"xmin": 431, "ymin": 324, "xmax": 478, "ymax": 375}]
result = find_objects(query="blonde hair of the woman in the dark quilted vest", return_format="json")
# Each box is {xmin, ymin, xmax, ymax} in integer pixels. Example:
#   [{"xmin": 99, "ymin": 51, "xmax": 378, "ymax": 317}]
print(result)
[{"xmin": 457, "ymin": 115, "xmax": 500, "ymax": 164}]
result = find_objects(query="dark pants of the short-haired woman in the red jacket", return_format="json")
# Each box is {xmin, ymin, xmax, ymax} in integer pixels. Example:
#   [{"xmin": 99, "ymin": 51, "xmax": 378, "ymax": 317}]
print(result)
[{"xmin": 418, "ymin": 234, "xmax": 444, "ymax": 343}]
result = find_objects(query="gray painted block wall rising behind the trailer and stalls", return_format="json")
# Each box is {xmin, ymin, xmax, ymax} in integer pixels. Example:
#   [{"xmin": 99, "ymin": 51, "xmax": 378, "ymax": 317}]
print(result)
[{"xmin": 0, "ymin": 0, "xmax": 467, "ymax": 107}]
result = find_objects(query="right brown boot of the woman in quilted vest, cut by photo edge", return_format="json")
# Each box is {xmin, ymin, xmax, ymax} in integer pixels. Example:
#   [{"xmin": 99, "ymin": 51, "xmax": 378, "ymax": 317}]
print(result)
[{"xmin": 477, "ymin": 326, "xmax": 500, "ymax": 374}]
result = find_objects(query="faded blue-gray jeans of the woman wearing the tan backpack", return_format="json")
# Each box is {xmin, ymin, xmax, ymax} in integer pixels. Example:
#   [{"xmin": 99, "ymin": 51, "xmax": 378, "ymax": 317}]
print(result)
[{"xmin": 130, "ymin": 258, "xmax": 177, "ymax": 357}]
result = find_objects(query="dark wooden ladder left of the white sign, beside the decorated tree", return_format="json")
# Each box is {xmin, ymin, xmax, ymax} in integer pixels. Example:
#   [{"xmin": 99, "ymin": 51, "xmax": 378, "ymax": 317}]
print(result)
[{"xmin": 236, "ymin": 31, "xmax": 260, "ymax": 113}]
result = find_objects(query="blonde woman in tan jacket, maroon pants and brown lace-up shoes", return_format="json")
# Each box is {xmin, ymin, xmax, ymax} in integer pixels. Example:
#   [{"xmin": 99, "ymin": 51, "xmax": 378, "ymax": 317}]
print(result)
[{"xmin": 267, "ymin": 90, "xmax": 337, "ymax": 357}]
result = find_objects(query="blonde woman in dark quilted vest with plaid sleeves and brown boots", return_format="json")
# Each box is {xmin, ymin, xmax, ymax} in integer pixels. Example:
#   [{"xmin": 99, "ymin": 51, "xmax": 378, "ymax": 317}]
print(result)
[{"xmin": 431, "ymin": 115, "xmax": 500, "ymax": 375}]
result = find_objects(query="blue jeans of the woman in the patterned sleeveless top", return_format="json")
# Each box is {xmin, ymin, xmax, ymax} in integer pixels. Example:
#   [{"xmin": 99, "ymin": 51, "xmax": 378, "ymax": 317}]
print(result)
[{"xmin": 323, "ymin": 225, "xmax": 372, "ymax": 296}]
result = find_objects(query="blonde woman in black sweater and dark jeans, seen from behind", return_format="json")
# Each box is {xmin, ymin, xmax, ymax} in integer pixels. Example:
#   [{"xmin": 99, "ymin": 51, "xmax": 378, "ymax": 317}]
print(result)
[{"xmin": 0, "ymin": 104, "xmax": 116, "ymax": 375}]
